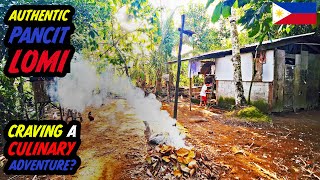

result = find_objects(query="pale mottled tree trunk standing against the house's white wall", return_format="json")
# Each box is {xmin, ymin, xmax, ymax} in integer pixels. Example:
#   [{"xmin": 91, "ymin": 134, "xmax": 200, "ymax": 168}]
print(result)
[{"xmin": 230, "ymin": 9, "xmax": 246, "ymax": 107}]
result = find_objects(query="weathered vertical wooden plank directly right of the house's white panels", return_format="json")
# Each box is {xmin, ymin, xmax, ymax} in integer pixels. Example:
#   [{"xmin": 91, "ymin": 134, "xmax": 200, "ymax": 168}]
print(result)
[{"xmin": 272, "ymin": 49, "xmax": 286, "ymax": 112}]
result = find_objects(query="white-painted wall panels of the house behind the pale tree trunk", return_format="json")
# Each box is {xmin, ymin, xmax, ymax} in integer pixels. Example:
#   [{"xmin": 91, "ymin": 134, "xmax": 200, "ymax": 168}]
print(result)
[{"xmin": 215, "ymin": 50, "xmax": 274, "ymax": 103}]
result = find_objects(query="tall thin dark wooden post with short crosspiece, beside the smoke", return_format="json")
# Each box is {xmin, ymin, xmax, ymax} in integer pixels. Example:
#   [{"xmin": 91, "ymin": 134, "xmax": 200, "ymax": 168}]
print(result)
[{"xmin": 173, "ymin": 14, "xmax": 185, "ymax": 119}]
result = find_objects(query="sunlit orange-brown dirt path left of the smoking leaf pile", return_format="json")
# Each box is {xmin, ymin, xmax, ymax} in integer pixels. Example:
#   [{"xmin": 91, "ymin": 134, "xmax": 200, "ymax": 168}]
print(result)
[{"xmin": 68, "ymin": 100, "xmax": 147, "ymax": 180}]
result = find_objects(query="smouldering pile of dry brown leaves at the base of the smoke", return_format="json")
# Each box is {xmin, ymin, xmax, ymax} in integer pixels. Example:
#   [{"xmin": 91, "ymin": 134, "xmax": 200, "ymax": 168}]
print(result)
[{"xmin": 146, "ymin": 145, "xmax": 219, "ymax": 179}]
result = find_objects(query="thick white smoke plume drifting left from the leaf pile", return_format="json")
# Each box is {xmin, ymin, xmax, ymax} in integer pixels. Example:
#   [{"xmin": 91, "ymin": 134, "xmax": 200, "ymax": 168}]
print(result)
[{"xmin": 49, "ymin": 56, "xmax": 185, "ymax": 147}]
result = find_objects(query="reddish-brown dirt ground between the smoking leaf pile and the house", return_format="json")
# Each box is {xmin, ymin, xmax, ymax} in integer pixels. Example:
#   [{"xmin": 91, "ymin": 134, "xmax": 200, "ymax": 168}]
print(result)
[{"xmin": 163, "ymin": 103, "xmax": 320, "ymax": 179}]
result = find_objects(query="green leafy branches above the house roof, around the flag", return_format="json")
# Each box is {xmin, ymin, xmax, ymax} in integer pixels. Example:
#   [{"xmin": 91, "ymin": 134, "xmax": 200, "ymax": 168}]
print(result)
[{"xmin": 207, "ymin": 0, "xmax": 320, "ymax": 41}]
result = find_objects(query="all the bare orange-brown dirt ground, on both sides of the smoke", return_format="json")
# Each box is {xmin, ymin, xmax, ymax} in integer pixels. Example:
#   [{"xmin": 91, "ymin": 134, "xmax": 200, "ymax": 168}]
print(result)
[{"xmin": 0, "ymin": 100, "xmax": 320, "ymax": 180}]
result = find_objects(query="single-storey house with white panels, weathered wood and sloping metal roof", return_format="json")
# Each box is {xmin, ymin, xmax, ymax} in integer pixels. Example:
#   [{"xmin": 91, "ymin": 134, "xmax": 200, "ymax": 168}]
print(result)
[{"xmin": 170, "ymin": 33, "xmax": 320, "ymax": 112}]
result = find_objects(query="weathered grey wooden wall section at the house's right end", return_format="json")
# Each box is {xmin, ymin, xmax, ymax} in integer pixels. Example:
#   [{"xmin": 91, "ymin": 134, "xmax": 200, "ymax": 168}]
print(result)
[{"xmin": 271, "ymin": 50, "xmax": 320, "ymax": 112}]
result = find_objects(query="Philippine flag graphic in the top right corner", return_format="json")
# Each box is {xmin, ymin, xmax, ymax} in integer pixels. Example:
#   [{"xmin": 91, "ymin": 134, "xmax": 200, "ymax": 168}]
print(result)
[{"xmin": 272, "ymin": 2, "xmax": 317, "ymax": 24}]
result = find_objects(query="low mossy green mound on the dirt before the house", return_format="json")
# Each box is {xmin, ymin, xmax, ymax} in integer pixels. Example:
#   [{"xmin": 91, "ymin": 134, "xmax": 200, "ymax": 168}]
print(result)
[{"xmin": 236, "ymin": 106, "xmax": 271, "ymax": 122}]
